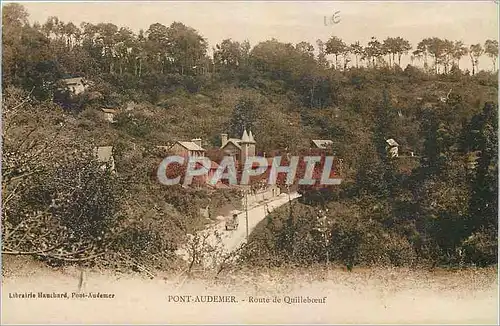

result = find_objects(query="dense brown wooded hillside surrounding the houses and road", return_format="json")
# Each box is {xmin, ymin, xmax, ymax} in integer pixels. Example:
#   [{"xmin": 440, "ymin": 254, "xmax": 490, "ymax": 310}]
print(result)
[{"xmin": 2, "ymin": 3, "xmax": 498, "ymax": 268}]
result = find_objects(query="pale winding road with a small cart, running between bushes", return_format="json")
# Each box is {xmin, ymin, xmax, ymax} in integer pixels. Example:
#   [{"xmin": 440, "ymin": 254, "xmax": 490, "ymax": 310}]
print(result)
[{"xmin": 177, "ymin": 193, "xmax": 300, "ymax": 260}]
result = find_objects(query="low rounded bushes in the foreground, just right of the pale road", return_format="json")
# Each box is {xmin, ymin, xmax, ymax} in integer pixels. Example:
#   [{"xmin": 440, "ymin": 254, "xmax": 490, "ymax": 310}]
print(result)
[{"xmin": 242, "ymin": 203, "xmax": 417, "ymax": 267}]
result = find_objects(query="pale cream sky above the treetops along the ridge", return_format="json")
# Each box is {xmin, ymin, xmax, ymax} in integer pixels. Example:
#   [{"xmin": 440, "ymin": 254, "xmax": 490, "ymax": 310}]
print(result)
[{"xmin": 4, "ymin": 0, "xmax": 499, "ymax": 69}]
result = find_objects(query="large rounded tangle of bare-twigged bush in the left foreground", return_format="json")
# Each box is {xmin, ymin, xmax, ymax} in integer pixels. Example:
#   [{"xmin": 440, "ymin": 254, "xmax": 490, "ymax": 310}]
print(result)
[{"xmin": 2, "ymin": 152, "xmax": 121, "ymax": 263}]
